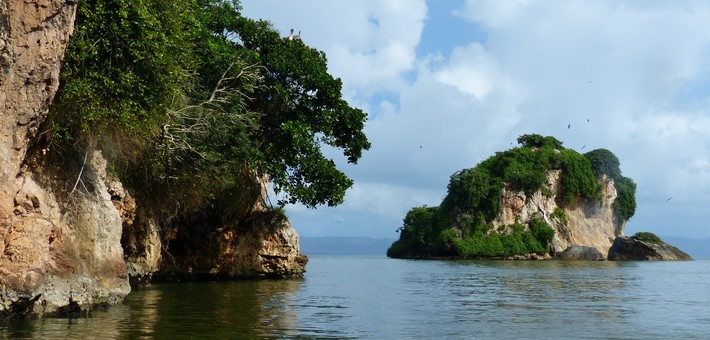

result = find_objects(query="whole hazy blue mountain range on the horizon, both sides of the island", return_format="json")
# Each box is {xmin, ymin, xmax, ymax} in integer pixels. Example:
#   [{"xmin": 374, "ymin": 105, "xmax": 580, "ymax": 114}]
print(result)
[{"xmin": 301, "ymin": 236, "xmax": 710, "ymax": 259}]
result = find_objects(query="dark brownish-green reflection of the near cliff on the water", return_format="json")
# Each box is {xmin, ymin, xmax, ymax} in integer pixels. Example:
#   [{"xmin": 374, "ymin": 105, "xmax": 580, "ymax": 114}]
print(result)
[{"xmin": 0, "ymin": 280, "xmax": 303, "ymax": 339}]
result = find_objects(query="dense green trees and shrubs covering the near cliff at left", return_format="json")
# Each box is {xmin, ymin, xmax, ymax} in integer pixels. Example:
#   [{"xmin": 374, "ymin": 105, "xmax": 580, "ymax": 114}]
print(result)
[{"xmin": 42, "ymin": 0, "xmax": 370, "ymax": 216}]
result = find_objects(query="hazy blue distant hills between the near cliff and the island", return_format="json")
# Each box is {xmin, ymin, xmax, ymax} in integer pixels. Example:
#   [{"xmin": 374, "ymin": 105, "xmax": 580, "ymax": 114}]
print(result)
[{"xmin": 300, "ymin": 237, "xmax": 395, "ymax": 256}]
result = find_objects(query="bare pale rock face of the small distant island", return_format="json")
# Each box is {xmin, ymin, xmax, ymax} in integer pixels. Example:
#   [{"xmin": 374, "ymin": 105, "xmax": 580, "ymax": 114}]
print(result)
[{"xmin": 493, "ymin": 170, "xmax": 625, "ymax": 254}]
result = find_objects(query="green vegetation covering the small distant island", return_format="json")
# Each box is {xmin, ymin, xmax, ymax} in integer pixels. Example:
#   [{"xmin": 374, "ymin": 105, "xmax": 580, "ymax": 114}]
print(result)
[{"xmin": 387, "ymin": 134, "xmax": 636, "ymax": 258}]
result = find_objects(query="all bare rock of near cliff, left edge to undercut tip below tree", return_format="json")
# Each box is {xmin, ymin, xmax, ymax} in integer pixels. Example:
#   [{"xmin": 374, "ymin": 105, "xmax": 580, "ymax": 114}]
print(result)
[{"xmin": 0, "ymin": 0, "xmax": 307, "ymax": 318}]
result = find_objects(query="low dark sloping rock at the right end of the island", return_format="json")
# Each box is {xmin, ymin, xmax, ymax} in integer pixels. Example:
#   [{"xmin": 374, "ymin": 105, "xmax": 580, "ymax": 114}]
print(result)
[{"xmin": 608, "ymin": 236, "xmax": 692, "ymax": 261}]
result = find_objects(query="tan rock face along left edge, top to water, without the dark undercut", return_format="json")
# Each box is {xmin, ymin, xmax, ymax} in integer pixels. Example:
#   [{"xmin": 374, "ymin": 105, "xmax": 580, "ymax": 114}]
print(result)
[{"xmin": 0, "ymin": 0, "xmax": 130, "ymax": 318}]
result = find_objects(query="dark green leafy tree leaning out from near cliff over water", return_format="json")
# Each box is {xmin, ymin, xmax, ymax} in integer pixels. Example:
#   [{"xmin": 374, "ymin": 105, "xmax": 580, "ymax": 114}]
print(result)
[{"xmin": 234, "ymin": 18, "xmax": 370, "ymax": 207}]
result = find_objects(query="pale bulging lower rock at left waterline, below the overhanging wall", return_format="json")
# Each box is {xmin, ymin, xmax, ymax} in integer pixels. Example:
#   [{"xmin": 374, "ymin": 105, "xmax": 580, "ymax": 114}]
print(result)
[{"xmin": 0, "ymin": 151, "xmax": 130, "ymax": 317}]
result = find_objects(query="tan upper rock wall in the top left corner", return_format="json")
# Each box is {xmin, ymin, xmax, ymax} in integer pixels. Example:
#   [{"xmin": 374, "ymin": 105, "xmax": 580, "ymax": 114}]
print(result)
[{"xmin": 0, "ymin": 0, "xmax": 76, "ymax": 212}]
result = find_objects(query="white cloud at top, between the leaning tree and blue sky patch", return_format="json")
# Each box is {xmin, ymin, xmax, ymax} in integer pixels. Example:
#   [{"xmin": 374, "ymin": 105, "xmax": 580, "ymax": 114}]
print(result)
[{"xmin": 242, "ymin": 0, "xmax": 427, "ymax": 100}]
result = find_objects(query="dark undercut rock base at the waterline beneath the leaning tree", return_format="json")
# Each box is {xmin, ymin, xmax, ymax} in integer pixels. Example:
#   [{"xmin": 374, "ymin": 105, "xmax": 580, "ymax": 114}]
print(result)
[{"xmin": 123, "ymin": 171, "xmax": 308, "ymax": 285}]
